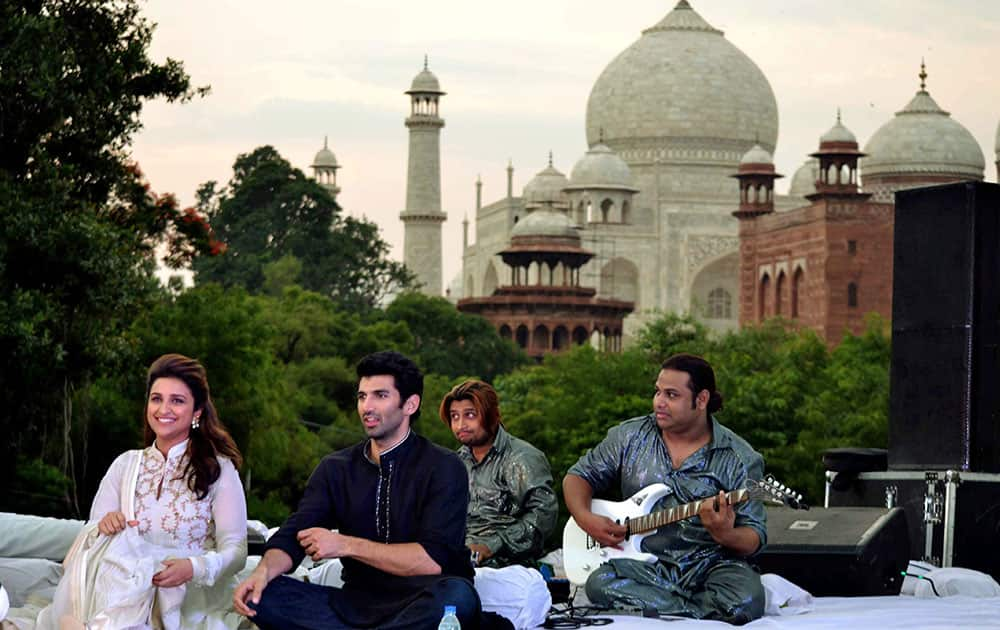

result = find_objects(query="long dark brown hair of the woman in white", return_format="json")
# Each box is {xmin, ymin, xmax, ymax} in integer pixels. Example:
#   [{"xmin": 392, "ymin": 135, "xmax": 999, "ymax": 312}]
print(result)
[{"xmin": 142, "ymin": 354, "xmax": 243, "ymax": 500}]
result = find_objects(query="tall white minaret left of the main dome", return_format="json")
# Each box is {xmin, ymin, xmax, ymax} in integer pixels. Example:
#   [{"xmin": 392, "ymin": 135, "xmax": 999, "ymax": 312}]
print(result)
[{"xmin": 399, "ymin": 56, "xmax": 447, "ymax": 296}]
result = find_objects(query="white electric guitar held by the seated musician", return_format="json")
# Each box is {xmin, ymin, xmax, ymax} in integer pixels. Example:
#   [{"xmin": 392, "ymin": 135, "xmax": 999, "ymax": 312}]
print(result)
[{"xmin": 563, "ymin": 476, "xmax": 808, "ymax": 585}]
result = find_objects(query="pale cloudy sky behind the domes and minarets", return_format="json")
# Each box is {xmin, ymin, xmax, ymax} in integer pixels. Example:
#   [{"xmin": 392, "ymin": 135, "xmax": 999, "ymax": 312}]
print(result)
[{"xmin": 132, "ymin": 0, "xmax": 1000, "ymax": 286}]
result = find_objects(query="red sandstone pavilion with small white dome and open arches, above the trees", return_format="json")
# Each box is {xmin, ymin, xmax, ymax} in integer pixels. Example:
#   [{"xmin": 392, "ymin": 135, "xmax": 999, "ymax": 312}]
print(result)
[{"xmin": 458, "ymin": 207, "xmax": 634, "ymax": 359}]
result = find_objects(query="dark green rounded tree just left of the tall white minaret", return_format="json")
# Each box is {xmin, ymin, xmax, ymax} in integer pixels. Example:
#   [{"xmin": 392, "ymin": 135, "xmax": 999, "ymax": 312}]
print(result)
[{"xmin": 194, "ymin": 146, "xmax": 413, "ymax": 308}]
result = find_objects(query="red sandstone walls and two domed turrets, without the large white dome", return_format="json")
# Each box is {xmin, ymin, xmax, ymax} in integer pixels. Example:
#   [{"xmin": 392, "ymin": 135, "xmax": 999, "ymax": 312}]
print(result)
[{"xmin": 733, "ymin": 115, "xmax": 893, "ymax": 344}]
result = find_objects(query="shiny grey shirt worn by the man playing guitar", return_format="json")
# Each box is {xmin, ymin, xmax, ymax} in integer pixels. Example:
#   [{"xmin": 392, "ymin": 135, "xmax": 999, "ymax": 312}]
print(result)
[{"xmin": 568, "ymin": 415, "xmax": 767, "ymax": 574}]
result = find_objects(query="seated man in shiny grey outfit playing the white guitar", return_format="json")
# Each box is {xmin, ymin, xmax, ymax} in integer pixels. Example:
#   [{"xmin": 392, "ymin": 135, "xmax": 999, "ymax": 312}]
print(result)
[{"xmin": 563, "ymin": 354, "xmax": 767, "ymax": 624}]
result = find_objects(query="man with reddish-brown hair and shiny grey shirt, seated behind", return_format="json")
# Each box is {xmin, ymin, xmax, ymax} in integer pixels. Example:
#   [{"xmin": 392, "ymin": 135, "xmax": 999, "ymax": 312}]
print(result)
[{"xmin": 440, "ymin": 380, "xmax": 559, "ymax": 568}]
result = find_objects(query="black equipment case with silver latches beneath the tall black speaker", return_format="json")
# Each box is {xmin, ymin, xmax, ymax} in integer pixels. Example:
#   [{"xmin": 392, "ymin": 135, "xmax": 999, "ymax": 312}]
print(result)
[{"xmin": 826, "ymin": 471, "xmax": 1000, "ymax": 580}]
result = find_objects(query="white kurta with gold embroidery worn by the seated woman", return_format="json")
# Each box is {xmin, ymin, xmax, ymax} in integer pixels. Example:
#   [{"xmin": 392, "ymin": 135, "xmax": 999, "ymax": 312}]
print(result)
[{"xmin": 90, "ymin": 441, "xmax": 247, "ymax": 629}]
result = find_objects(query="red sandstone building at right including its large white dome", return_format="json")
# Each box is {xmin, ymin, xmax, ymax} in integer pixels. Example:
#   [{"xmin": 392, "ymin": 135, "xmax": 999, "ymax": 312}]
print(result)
[{"xmin": 733, "ymin": 64, "xmax": 984, "ymax": 344}]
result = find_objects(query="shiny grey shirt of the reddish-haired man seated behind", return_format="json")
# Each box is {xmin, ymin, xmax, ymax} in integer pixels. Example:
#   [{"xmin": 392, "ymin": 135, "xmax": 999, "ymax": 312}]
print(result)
[{"xmin": 458, "ymin": 426, "xmax": 559, "ymax": 566}]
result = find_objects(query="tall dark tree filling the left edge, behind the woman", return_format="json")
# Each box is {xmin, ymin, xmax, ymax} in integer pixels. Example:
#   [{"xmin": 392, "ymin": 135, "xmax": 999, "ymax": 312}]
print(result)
[{"xmin": 0, "ymin": 0, "xmax": 209, "ymax": 514}]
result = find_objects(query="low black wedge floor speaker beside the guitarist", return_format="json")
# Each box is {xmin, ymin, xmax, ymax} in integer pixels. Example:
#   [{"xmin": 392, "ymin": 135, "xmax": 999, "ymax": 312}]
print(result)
[{"xmin": 752, "ymin": 507, "xmax": 910, "ymax": 596}]
